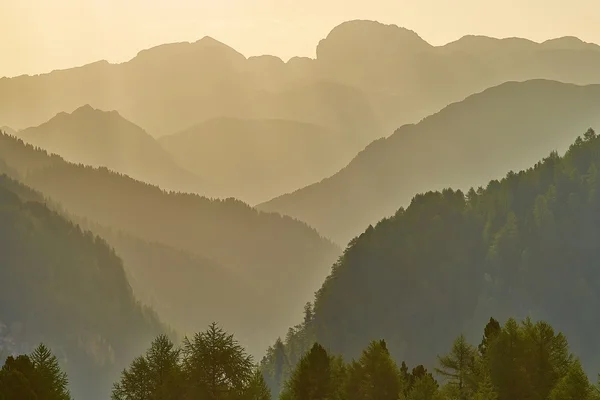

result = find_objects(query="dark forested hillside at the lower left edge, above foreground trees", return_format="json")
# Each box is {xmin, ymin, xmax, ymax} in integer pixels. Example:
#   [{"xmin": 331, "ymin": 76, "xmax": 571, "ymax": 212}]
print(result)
[{"xmin": 0, "ymin": 175, "xmax": 165, "ymax": 400}]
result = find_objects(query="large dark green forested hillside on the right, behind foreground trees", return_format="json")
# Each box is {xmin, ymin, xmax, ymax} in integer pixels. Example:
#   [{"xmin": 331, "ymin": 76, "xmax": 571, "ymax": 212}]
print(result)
[{"xmin": 262, "ymin": 129, "xmax": 600, "ymax": 398}]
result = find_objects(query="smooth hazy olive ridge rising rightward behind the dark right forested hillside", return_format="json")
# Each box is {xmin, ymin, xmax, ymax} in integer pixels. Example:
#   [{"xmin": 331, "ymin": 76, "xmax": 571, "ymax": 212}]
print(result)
[{"xmin": 258, "ymin": 80, "xmax": 600, "ymax": 243}]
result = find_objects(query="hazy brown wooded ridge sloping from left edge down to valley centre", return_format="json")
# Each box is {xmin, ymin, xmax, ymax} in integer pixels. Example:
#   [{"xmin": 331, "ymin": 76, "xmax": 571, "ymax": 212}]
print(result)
[{"xmin": 0, "ymin": 135, "xmax": 340, "ymax": 354}]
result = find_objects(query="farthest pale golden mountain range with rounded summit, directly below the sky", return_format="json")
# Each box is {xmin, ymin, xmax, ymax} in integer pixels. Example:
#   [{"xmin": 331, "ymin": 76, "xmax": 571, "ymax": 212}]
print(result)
[{"xmin": 0, "ymin": 21, "xmax": 600, "ymax": 144}]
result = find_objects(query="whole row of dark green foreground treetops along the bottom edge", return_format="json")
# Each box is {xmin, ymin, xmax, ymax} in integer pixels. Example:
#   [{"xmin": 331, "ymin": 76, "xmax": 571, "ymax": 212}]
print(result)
[{"xmin": 0, "ymin": 318, "xmax": 600, "ymax": 400}]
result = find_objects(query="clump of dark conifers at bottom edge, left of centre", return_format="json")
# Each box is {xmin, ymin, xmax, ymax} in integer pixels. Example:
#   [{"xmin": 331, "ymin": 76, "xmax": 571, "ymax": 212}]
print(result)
[{"xmin": 112, "ymin": 323, "xmax": 264, "ymax": 400}]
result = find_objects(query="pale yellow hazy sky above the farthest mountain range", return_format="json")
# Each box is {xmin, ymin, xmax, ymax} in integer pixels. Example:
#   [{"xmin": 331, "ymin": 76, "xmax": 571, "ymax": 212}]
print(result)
[{"xmin": 0, "ymin": 0, "xmax": 600, "ymax": 76}]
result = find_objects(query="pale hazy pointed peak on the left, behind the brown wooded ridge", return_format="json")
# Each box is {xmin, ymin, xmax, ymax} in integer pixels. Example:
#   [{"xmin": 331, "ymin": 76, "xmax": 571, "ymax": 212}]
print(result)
[{"xmin": 17, "ymin": 105, "xmax": 207, "ymax": 193}]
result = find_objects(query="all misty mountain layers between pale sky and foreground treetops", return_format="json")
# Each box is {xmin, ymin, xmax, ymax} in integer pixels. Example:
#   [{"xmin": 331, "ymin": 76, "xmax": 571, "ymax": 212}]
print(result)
[{"xmin": 0, "ymin": 15, "xmax": 600, "ymax": 400}]
